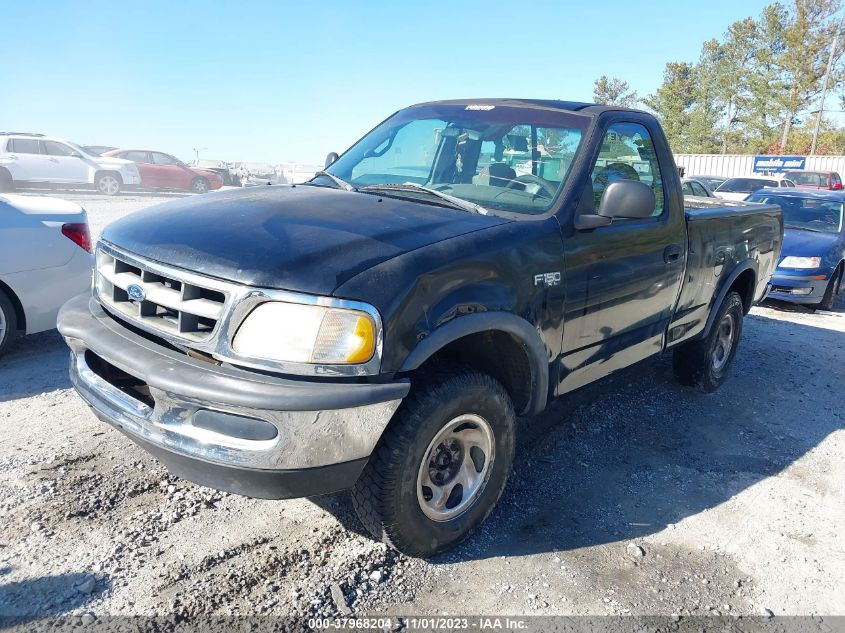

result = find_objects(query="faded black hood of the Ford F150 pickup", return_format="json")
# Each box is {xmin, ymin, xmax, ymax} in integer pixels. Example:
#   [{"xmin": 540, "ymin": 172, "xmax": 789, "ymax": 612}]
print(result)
[{"xmin": 102, "ymin": 185, "xmax": 509, "ymax": 295}]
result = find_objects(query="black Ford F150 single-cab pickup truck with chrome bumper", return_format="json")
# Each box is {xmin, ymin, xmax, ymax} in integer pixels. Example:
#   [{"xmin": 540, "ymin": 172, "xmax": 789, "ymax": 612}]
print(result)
[{"xmin": 59, "ymin": 99, "xmax": 783, "ymax": 555}]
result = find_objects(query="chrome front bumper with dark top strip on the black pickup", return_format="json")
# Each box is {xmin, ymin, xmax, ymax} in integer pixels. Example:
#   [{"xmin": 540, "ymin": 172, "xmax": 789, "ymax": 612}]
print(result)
[{"xmin": 59, "ymin": 296, "xmax": 410, "ymax": 497}]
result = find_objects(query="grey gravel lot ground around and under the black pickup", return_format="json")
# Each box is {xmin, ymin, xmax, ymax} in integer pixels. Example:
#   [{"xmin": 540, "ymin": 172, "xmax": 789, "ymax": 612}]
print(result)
[{"xmin": 0, "ymin": 194, "xmax": 845, "ymax": 622}]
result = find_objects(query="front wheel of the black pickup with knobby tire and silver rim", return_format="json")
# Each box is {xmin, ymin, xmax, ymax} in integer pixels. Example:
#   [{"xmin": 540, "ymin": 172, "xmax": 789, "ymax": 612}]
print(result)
[{"xmin": 352, "ymin": 366, "xmax": 515, "ymax": 557}]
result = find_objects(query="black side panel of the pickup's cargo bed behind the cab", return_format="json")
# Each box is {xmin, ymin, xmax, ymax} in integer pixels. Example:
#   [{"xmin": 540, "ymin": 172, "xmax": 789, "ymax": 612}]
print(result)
[{"xmin": 667, "ymin": 197, "xmax": 783, "ymax": 346}]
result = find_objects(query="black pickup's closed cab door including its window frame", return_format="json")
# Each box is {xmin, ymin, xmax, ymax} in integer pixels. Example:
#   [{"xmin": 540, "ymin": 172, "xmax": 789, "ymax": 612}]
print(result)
[{"xmin": 558, "ymin": 120, "xmax": 686, "ymax": 393}]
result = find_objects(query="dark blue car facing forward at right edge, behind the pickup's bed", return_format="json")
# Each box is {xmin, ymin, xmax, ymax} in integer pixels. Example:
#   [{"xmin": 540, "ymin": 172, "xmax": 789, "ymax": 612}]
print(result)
[{"xmin": 747, "ymin": 188, "xmax": 845, "ymax": 310}]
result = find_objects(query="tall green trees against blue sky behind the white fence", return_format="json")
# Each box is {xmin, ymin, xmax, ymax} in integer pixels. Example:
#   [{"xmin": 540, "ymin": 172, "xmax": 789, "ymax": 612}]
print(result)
[{"xmin": 593, "ymin": 0, "xmax": 845, "ymax": 155}]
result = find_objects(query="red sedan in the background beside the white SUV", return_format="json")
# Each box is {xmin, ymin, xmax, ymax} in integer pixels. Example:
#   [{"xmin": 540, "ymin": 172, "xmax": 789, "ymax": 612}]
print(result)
[{"xmin": 103, "ymin": 149, "xmax": 223, "ymax": 193}]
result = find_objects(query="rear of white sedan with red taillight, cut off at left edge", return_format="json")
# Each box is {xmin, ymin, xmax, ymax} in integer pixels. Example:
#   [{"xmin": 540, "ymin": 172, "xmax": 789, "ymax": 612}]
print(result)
[{"xmin": 0, "ymin": 194, "xmax": 93, "ymax": 355}]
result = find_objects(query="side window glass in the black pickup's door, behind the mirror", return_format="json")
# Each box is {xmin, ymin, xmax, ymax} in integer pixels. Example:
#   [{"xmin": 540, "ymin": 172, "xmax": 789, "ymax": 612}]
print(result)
[{"xmin": 591, "ymin": 123, "xmax": 664, "ymax": 217}]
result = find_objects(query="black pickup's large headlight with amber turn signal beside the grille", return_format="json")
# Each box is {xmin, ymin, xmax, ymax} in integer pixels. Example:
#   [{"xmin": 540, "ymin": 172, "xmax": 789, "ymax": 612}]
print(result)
[{"xmin": 232, "ymin": 301, "xmax": 378, "ymax": 365}]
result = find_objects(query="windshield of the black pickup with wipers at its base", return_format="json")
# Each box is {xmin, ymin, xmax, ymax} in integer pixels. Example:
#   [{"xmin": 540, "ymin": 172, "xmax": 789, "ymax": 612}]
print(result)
[{"xmin": 327, "ymin": 104, "xmax": 590, "ymax": 214}]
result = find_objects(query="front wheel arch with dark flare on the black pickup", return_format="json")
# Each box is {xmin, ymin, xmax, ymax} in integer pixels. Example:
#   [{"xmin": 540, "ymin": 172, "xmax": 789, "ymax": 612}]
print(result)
[{"xmin": 399, "ymin": 312, "xmax": 549, "ymax": 415}]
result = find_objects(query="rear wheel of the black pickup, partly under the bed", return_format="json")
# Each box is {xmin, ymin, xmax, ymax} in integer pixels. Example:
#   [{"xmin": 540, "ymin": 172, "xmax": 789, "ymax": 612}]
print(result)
[{"xmin": 672, "ymin": 292, "xmax": 745, "ymax": 393}]
